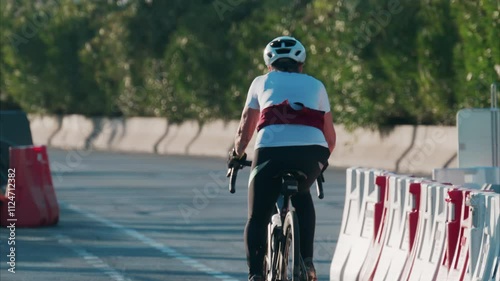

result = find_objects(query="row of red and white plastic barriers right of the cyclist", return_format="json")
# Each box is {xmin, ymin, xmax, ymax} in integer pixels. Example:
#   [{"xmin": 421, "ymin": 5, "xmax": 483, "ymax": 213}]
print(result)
[{"xmin": 330, "ymin": 168, "xmax": 500, "ymax": 281}]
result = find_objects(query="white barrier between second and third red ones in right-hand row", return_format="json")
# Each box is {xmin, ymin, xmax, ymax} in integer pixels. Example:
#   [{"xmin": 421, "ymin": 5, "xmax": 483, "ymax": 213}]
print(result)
[{"xmin": 399, "ymin": 182, "xmax": 450, "ymax": 281}]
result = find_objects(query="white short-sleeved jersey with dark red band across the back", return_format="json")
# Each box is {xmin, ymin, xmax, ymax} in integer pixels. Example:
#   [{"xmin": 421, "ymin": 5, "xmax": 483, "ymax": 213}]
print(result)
[{"xmin": 245, "ymin": 71, "xmax": 330, "ymax": 149}]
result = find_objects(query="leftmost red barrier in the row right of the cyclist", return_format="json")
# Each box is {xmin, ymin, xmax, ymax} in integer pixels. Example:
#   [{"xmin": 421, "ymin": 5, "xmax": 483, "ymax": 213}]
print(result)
[{"xmin": 358, "ymin": 176, "xmax": 390, "ymax": 281}]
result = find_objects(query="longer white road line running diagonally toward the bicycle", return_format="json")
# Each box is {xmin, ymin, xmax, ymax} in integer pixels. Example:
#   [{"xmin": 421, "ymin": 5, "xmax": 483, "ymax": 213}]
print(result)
[{"xmin": 60, "ymin": 202, "xmax": 238, "ymax": 281}]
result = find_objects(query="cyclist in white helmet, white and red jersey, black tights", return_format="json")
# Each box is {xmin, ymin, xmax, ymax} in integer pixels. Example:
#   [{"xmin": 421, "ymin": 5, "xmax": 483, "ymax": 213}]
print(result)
[{"xmin": 228, "ymin": 36, "xmax": 336, "ymax": 281}]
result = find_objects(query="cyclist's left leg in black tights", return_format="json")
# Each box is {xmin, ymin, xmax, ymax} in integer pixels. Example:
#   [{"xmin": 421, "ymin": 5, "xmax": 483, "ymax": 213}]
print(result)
[{"xmin": 244, "ymin": 148, "xmax": 281, "ymax": 276}]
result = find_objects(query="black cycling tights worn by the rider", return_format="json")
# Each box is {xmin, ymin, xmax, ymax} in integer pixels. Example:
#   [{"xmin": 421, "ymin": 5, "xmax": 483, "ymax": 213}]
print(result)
[{"xmin": 244, "ymin": 145, "xmax": 330, "ymax": 275}]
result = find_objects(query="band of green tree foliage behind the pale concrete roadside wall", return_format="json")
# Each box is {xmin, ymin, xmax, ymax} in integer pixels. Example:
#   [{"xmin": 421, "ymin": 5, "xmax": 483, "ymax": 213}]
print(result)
[{"xmin": 0, "ymin": 0, "xmax": 500, "ymax": 127}]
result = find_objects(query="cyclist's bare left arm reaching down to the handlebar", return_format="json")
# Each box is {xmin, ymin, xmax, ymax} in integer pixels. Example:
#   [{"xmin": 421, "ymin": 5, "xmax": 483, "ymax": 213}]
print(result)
[{"xmin": 234, "ymin": 106, "xmax": 260, "ymax": 155}]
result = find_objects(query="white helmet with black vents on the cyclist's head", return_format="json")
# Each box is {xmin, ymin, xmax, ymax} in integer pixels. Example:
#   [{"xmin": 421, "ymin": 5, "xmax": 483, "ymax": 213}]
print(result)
[{"xmin": 264, "ymin": 36, "xmax": 306, "ymax": 66}]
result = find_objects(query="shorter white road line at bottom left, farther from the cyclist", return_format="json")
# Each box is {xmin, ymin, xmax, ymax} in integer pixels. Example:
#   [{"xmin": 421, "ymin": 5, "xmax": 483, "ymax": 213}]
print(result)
[{"xmin": 55, "ymin": 234, "xmax": 131, "ymax": 281}]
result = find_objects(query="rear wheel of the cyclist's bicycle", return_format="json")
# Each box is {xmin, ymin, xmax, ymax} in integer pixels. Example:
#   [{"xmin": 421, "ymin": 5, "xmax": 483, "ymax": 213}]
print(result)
[{"xmin": 280, "ymin": 211, "xmax": 305, "ymax": 281}]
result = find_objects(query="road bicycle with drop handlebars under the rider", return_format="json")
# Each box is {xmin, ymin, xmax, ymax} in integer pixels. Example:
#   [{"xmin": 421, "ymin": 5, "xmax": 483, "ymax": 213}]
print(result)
[{"xmin": 227, "ymin": 161, "xmax": 326, "ymax": 281}]
